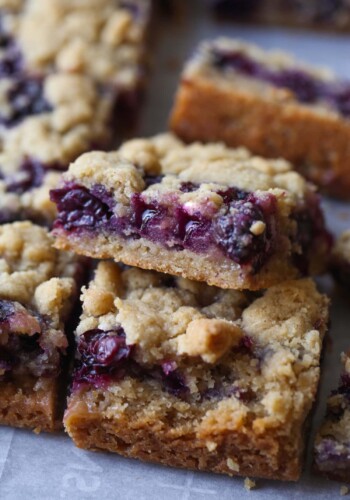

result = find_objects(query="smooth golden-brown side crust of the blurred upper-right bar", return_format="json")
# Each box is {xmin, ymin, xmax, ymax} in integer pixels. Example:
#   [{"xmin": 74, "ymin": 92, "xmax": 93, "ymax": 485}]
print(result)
[{"xmin": 170, "ymin": 77, "xmax": 350, "ymax": 198}]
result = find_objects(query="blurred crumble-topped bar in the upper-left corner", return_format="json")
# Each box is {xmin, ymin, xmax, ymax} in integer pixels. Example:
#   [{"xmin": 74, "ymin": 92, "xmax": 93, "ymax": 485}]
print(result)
[{"xmin": 0, "ymin": 0, "xmax": 150, "ymax": 225}]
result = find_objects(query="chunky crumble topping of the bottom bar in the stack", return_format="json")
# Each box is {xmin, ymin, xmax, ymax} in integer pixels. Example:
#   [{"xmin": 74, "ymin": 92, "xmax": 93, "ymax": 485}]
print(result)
[{"xmin": 76, "ymin": 262, "xmax": 328, "ymax": 432}]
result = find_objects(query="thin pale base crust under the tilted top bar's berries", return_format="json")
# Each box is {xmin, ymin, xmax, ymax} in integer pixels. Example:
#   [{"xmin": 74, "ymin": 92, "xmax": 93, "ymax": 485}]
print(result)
[{"xmin": 54, "ymin": 230, "xmax": 306, "ymax": 290}]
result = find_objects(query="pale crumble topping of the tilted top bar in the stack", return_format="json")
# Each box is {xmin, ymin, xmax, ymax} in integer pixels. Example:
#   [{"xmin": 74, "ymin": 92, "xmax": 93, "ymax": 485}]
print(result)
[{"xmin": 65, "ymin": 134, "xmax": 310, "ymax": 207}]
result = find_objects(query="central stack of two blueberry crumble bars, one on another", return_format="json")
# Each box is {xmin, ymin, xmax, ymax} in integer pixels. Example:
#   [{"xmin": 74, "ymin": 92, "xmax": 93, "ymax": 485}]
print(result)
[{"xmin": 51, "ymin": 134, "xmax": 330, "ymax": 480}]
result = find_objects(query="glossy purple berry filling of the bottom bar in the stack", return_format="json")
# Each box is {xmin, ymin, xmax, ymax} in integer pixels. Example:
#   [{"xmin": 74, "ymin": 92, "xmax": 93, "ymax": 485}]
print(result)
[{"xmin": 73, "ymin": 326, "xmax": 256, "ymax": 403}]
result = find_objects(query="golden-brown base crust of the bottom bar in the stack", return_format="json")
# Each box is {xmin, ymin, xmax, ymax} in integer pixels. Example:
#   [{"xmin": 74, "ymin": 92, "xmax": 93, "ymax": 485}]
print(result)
[{"xmin": 64, "ymin": 393, "xmax": 304, "ymax": 481}]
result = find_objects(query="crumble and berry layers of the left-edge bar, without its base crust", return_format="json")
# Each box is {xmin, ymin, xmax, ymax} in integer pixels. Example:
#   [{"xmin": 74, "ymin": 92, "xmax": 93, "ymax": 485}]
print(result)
[{"xmin": 0, "ymin": 222, "xmax": 81, "ymax": 381}]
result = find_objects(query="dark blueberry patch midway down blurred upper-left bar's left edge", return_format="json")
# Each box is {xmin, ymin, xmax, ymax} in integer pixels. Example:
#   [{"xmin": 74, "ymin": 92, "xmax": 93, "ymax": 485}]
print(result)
[{"xmin": 0, "ymin": 76, "xmax": 52, "ymax": 127}]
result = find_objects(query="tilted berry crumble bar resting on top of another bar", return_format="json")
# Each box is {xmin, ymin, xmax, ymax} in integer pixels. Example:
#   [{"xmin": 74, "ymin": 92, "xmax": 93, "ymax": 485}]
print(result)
[{"xmin": 51, "ymin": 134, "xmax": 330, "ymax": 289}]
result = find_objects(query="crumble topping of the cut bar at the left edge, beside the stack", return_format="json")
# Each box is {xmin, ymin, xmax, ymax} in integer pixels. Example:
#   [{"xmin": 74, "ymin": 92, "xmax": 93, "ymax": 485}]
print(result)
[{"xmin": 0, "ymin": 222, "xmax": 78, "ymax": 306}]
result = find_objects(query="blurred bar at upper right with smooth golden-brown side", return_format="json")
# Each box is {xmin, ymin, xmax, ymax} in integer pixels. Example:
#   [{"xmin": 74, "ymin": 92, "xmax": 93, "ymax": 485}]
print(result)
[{"xmin": 171, "ymin": 38, "xmax": 350, "ymax": 198}]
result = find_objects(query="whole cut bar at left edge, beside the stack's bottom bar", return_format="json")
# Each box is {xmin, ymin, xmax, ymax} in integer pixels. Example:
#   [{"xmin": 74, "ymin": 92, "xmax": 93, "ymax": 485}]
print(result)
[{"xmin": 0, "ymin": 222, "xmax": 82, "ymax": 431}]
